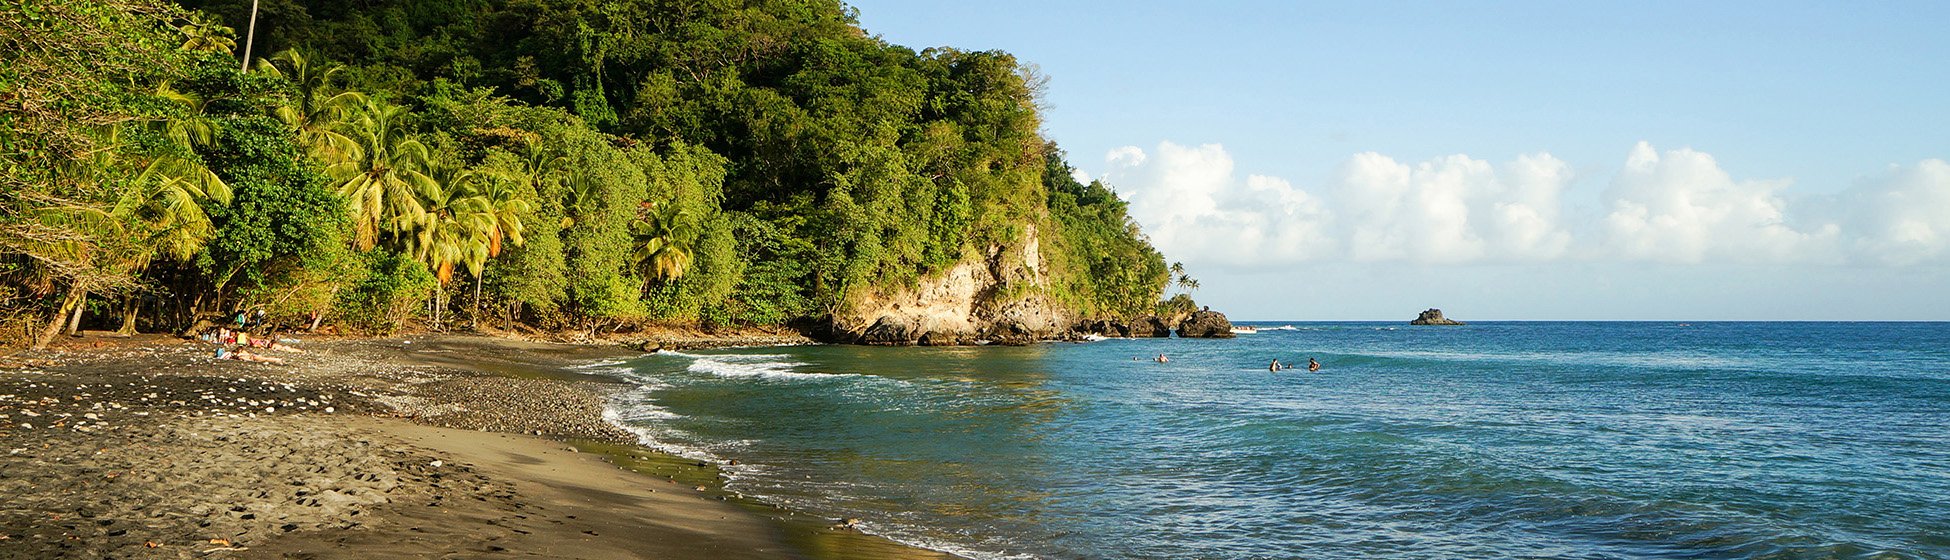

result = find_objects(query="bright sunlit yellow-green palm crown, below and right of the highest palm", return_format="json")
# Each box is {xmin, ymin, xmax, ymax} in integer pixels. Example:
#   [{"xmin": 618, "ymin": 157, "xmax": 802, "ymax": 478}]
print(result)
[{"xmin": 326, "ymin": 100, "xmax": 441, "ymax": 250}]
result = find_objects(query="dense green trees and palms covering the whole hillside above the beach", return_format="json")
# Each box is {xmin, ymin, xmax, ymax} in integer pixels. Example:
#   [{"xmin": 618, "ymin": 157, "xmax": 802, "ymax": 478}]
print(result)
[{"xmin": 0, "ymin": 0, "xmax": 1170, "ymax": 345}]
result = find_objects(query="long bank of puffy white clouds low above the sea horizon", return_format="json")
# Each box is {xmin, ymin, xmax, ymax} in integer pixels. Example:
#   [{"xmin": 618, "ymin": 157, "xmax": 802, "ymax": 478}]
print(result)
[{"xmin": 1102, "ymin": 142, "xmax": 1950, "ymax": 265}]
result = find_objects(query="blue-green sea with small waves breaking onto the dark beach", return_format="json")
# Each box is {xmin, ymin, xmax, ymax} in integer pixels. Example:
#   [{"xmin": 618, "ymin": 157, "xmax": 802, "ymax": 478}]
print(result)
[{"xmin": 596, "ymin": 322, "xmax": 1950, "ymax": 558}]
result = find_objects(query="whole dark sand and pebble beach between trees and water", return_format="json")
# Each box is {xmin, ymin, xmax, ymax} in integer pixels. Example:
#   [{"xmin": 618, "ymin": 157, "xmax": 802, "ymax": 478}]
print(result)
[{"xmin": 0, "ymin": 334, "xmax": 959, "ymax": 558}]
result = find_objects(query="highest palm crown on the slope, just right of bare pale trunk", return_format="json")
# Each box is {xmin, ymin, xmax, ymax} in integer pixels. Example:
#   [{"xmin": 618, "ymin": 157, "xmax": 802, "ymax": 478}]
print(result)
[{"xmin": 257, "ymin": 49, "xmax": 367, "ymax": 164}]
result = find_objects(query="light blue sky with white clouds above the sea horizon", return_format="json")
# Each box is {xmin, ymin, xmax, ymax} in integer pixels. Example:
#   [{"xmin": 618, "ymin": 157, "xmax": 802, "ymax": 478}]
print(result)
[{"xmin": 848, "ymin": 0, "xmax": 1950, "ymax": 320}]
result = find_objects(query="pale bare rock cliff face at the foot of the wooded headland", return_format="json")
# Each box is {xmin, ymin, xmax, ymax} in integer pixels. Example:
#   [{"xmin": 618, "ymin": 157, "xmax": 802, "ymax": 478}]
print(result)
[{"xmin": 794, "ymin": 226, "xmax": 1073, "ymax": 345}]
